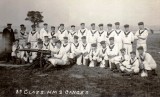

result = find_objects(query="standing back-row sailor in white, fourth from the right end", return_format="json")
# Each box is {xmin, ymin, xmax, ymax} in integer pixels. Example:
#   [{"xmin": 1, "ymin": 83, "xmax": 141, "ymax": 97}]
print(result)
[{"xmin": 106, "ymin": 24, "xmax": 115, "ymax": 45}]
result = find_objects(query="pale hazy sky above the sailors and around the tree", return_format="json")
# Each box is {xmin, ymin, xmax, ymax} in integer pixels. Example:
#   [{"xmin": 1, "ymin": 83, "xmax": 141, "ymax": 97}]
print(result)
[{"xmin": 0, "ymin": 0, "xmax": 160, "ymax": 26}]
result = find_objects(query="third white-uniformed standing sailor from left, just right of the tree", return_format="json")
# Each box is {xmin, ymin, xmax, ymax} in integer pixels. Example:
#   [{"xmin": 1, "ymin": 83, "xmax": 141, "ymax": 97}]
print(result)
[{"xmin": 39, "ymin": 23, "xmax": 50, "ymax": 41}]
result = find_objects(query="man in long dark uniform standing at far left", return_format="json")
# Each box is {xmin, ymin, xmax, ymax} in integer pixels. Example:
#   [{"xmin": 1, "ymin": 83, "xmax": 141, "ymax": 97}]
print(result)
[{"xmin": 2, "ymin": 24, "xmax": 15, "ymax": 62}]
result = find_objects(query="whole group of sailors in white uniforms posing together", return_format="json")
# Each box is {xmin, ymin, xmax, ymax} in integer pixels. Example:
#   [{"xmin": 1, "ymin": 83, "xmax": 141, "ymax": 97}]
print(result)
[{"xmin": 12, "ymin": 22, "xmax": 157, "ymax": 77}]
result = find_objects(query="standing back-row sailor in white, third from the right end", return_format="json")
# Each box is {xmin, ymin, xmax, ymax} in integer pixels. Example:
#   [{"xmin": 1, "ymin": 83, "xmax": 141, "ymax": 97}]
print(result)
[{"xmin": 115, "ymin": 22, "xmax": 124, "ymax": 53}]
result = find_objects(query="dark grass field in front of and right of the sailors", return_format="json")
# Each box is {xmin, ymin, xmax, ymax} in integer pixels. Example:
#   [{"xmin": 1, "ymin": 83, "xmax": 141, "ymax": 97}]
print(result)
[{"xmin": 0, "ymin": 33, "xmax": 160, "ymax": 97}]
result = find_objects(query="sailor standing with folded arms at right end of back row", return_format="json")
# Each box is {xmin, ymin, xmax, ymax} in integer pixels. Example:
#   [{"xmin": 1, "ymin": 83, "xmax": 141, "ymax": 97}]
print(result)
[{"xmin": 135, "ymin": 22, "xmax": 148, "ymax": 54}]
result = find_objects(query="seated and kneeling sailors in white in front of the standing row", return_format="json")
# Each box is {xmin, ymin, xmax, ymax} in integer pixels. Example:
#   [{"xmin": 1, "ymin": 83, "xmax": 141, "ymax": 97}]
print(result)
[{"xmin": 12, "ymin": 36, "xmax": 157, "ymax": 77}]
